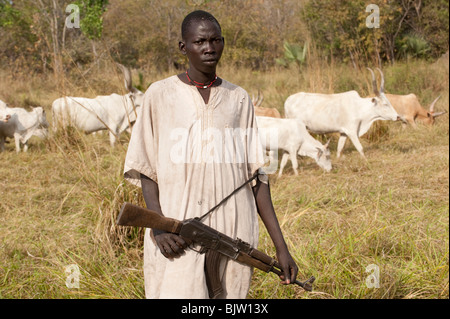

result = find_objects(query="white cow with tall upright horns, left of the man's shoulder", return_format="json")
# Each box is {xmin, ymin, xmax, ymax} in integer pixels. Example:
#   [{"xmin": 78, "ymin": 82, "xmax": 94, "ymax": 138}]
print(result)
[{"xmin": 52, "ymin": 65, "xmax": 144, "ymax": 146}]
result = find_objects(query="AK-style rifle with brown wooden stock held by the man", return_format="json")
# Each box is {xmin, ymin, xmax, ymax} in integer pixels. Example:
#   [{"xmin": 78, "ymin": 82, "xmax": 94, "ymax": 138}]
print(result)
[{"xmin": 116, "ymin": 203, "xmax": 315, "ymax": 297}]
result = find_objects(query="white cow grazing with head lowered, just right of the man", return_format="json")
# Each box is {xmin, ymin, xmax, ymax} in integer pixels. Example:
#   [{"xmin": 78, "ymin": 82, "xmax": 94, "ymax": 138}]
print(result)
[{"xmin": 256, "ymin": 116, "xmax": 331, "ymax": 177}]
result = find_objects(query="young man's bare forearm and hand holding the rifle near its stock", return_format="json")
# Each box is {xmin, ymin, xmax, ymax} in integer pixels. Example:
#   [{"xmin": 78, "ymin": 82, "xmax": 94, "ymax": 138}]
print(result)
[{"xmin": 141, "ymin": 174, "xmax": 188, "ymax": 259}]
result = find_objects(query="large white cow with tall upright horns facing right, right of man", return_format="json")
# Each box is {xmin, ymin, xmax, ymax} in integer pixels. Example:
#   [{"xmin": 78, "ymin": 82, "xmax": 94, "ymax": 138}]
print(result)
[{"xmin": 284, "ymin": 69, "xmax": 404, "ymax": 158}]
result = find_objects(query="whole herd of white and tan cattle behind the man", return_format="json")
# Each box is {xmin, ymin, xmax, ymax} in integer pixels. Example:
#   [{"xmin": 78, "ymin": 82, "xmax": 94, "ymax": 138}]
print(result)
[{"xmin": 0, "ymin": 64, "xmax": 446, "ymax": 176}]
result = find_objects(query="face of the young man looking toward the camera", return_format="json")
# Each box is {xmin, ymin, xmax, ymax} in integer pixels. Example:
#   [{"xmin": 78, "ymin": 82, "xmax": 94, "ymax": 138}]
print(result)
[{"xmin": 179, "ymin": 20, "xmax": 224, "ymax": 73}]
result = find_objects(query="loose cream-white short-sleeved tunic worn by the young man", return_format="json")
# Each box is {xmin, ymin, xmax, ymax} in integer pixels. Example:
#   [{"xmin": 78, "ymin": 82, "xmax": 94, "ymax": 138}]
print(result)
[{"xmin": 124, "ymin": 76, "xmax": 264, "ymax": 298}]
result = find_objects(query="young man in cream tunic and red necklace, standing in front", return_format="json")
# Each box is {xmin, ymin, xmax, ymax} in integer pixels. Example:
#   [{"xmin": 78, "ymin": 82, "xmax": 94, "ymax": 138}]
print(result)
[{"xmin": 124, "ymin": 11, "xmax": 298, "ymax": 298}]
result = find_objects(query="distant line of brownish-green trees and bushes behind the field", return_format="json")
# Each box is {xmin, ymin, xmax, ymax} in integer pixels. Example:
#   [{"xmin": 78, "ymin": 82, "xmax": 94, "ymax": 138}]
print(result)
[{"xmin": 0, "ymin": 0, "xmax": 449, "ymax": 75}]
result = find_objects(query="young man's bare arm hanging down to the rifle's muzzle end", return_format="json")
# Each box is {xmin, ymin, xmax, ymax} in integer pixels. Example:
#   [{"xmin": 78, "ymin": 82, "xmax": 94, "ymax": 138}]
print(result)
[{"xmin": 253, "ymin": 179, "xmax": 298, "ymax": 284}]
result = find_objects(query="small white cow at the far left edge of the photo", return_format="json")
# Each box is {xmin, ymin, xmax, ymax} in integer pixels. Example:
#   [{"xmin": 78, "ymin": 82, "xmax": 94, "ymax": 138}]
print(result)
[{"xmin": 0, "ymin": 106, "xmax": 49, "ymax": 152}]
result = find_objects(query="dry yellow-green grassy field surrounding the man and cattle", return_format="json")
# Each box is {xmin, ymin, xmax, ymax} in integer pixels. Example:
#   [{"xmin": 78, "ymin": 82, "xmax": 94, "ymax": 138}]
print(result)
[{"xmin": 0, "ymin": 62, "xmax": 449, "ymax": 299}]
